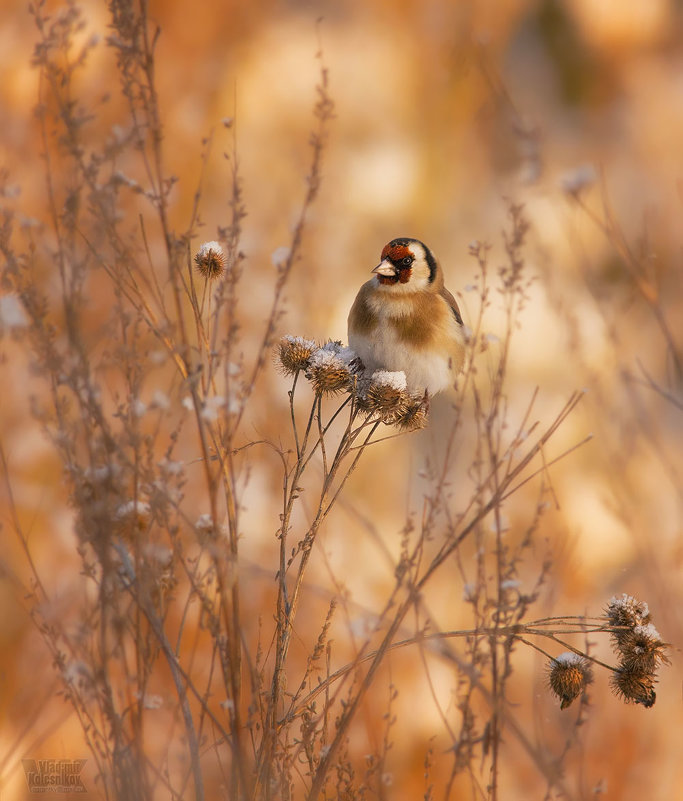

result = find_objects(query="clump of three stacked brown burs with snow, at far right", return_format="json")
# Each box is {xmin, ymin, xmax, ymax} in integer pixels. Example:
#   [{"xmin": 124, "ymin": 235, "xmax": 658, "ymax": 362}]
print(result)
[{"xmin": 606, "ymin": 595, "xmax": 669, "ymax": 708}]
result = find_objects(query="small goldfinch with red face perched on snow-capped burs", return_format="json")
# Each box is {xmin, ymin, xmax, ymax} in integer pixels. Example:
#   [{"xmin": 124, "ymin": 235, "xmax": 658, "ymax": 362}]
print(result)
[{"xmin": 348, "ymin": 237, "xmax": 465, "ymax": 397}]
